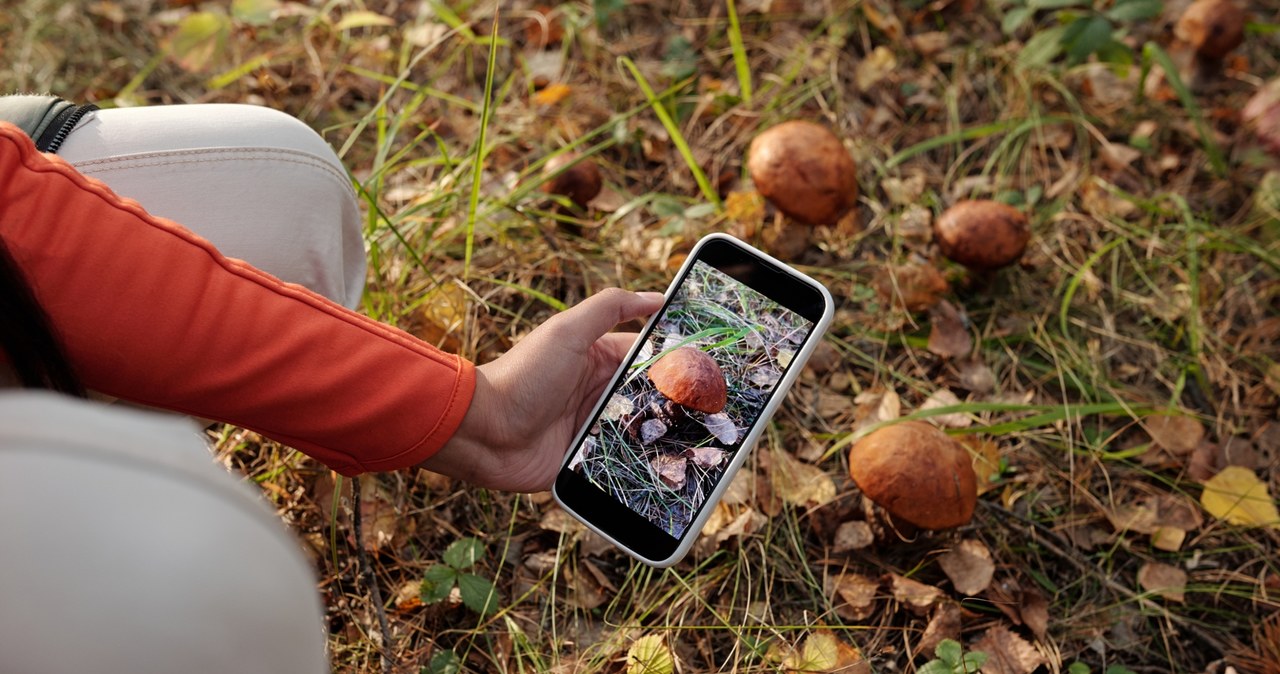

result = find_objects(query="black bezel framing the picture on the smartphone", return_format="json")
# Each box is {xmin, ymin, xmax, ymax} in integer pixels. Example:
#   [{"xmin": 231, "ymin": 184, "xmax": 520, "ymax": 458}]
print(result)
[{"xmin": 556, "ymin": 238, "xmax": 827, "ymax": 561}]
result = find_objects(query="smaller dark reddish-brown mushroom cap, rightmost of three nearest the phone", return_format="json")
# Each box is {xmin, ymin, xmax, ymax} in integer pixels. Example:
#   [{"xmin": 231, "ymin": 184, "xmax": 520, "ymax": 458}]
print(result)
[{"xmin": 933, "ymin": 200, "xmax": 1032, "ymax": 270}]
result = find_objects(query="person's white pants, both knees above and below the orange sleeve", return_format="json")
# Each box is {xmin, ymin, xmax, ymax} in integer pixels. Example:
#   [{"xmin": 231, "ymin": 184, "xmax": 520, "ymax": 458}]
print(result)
[{"xmin": 0, "ymin": 105, "xmax": 365, "ymax": 674}]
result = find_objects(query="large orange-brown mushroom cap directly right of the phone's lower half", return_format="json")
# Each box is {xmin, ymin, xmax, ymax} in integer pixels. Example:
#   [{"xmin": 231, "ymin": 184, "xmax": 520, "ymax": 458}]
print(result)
[{"xmin": 849, "ymin": 421, "xmax": 978, "ymax": 529}]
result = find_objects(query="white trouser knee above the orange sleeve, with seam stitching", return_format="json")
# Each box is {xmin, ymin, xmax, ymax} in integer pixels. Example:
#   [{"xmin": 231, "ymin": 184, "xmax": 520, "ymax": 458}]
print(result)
[{"xmin": 58, "ymin": 105, "xmax": 365, "ymax": 307}]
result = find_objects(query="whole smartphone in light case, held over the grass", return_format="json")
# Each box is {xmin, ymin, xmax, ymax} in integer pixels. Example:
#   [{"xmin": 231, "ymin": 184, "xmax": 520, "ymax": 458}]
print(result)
[{"xmin": 552, "ymin": 234, "xmax": 833, "ymax": 567}]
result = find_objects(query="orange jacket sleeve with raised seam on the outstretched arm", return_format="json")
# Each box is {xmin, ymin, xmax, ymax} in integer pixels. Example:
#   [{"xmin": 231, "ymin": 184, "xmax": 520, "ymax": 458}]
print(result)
[{"xmin": 0, "ymin": 123, "xmax": 475, "ymax": 474}]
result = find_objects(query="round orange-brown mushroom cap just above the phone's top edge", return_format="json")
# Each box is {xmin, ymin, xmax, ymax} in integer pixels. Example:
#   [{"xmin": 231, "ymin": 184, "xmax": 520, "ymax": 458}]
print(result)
[{"xmin": 746, "ymin": 119, "xmax": 858, "ymax": 225}]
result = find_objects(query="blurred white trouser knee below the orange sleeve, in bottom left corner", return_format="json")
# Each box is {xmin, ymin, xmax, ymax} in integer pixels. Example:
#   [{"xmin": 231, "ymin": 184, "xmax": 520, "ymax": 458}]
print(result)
[{"xmin": 0, "ymin": 390, "xmax": 328, "ymax": 674}]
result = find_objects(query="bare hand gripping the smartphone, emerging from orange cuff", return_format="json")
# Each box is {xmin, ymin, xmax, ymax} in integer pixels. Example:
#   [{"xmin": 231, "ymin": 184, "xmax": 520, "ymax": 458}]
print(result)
[{"xmin": 419, "ymin": 288, "xmax": 663, "ymax": 491}]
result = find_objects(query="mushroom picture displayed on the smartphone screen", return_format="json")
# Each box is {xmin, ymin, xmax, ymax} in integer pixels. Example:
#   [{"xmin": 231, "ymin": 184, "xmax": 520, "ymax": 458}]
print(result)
[{"xmin": 568, "ymin": 254, "xmax": 814, "ymax": 542}]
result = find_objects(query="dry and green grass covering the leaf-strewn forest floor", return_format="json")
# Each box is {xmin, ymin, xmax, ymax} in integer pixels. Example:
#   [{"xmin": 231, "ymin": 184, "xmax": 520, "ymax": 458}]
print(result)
[{"xmin": 0, "ymin": 0, "xmax": 1280, "ymax": 671}]
